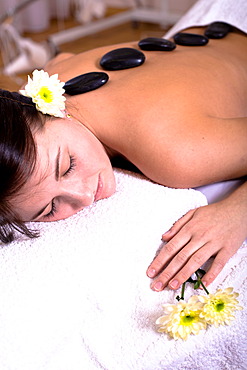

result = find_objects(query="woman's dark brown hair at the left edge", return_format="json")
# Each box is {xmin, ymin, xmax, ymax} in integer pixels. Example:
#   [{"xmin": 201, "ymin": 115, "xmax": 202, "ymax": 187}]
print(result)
[{"xmin": 0, "ymin": 89, "xmax": 44, "ymax": 243}]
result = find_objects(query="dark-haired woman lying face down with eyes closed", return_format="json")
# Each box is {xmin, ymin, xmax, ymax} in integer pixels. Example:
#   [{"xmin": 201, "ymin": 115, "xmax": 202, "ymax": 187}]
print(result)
[{"xmin": 0, "ymin": 24, "xmax": 247, "ymax": 291}]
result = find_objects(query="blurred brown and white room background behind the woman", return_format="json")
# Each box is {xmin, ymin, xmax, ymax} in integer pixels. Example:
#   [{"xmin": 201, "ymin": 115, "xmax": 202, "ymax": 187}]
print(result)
[{"xmin": 0, "ymin": 0, "xmax": 196, "ymax": 91}]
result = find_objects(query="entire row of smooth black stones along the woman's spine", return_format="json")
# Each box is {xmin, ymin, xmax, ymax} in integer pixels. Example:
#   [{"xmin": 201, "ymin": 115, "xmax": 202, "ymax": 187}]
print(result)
[{"xmin": 64, "ymin": 22, "xmax": 232, "ymax": 95}]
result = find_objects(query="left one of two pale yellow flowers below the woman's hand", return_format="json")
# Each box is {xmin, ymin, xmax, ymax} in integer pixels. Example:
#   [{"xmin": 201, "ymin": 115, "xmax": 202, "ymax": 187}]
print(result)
[{"xmin": 156, "ymin": 296, "xmax": 206, "ymax": 340}]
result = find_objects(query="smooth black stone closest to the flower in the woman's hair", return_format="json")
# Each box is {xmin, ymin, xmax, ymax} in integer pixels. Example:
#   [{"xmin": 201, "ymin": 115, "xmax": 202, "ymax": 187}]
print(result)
[{"xmin": 63, "ymin": 72, "xmax": 109, "ymax": 95}]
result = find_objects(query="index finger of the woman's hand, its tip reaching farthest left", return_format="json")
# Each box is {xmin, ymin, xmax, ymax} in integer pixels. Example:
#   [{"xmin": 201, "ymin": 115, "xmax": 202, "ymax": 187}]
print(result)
[{"xmin": 147, "ymin": 233, "xmax": 190, "ymax": 278}]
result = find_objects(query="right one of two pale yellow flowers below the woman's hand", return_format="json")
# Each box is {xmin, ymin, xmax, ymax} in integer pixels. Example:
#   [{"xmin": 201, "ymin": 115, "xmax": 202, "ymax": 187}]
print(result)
[{"xmin": 198, "ymin": 288, "xmax": 242, "ymax": 327}]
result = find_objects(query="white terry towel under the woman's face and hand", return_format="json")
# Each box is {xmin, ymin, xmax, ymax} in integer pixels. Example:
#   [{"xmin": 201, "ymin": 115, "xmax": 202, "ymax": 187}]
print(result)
[{"xmin": 0, "ymin": 170, "xmax": 247, "ymax": 370}]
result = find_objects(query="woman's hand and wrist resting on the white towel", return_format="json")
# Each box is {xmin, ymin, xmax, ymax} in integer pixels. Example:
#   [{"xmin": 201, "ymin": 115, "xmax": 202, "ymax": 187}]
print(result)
[{"xmin": 147, "ymin": 183, "xmax": 247, "ymax": 291}]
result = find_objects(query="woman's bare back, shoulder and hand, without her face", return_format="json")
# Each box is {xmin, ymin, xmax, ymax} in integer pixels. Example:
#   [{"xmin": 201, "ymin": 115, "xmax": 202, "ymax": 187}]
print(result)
[{"xmin": 39, "ymin": 28, "xmax": 247, "ymax": 291}]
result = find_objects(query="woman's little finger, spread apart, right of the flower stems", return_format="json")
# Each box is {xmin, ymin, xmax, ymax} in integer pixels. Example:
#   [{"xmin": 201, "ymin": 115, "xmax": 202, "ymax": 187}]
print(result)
[{"xmin": 202, "ymin": 248, "xmax": 234, "ymax": 286}]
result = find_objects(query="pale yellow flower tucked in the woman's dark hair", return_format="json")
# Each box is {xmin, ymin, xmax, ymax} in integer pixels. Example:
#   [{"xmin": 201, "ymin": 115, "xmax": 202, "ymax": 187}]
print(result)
[{"xmin": 20, "ymin": 69, "xmax": 66, "ymax": 118}]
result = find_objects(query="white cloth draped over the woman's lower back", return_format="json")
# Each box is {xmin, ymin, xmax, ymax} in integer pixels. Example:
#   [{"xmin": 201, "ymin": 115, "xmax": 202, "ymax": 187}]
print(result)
[{"xmin": 164, "ymin": 0, "xmax": 247, "ymax": 38}]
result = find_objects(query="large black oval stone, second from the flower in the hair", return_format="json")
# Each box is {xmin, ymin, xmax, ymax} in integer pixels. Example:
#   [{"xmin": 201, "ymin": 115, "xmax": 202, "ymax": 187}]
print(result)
[{"xmin": 100, "ymin": 48, "xmax": 145, "ymax": 71}]
